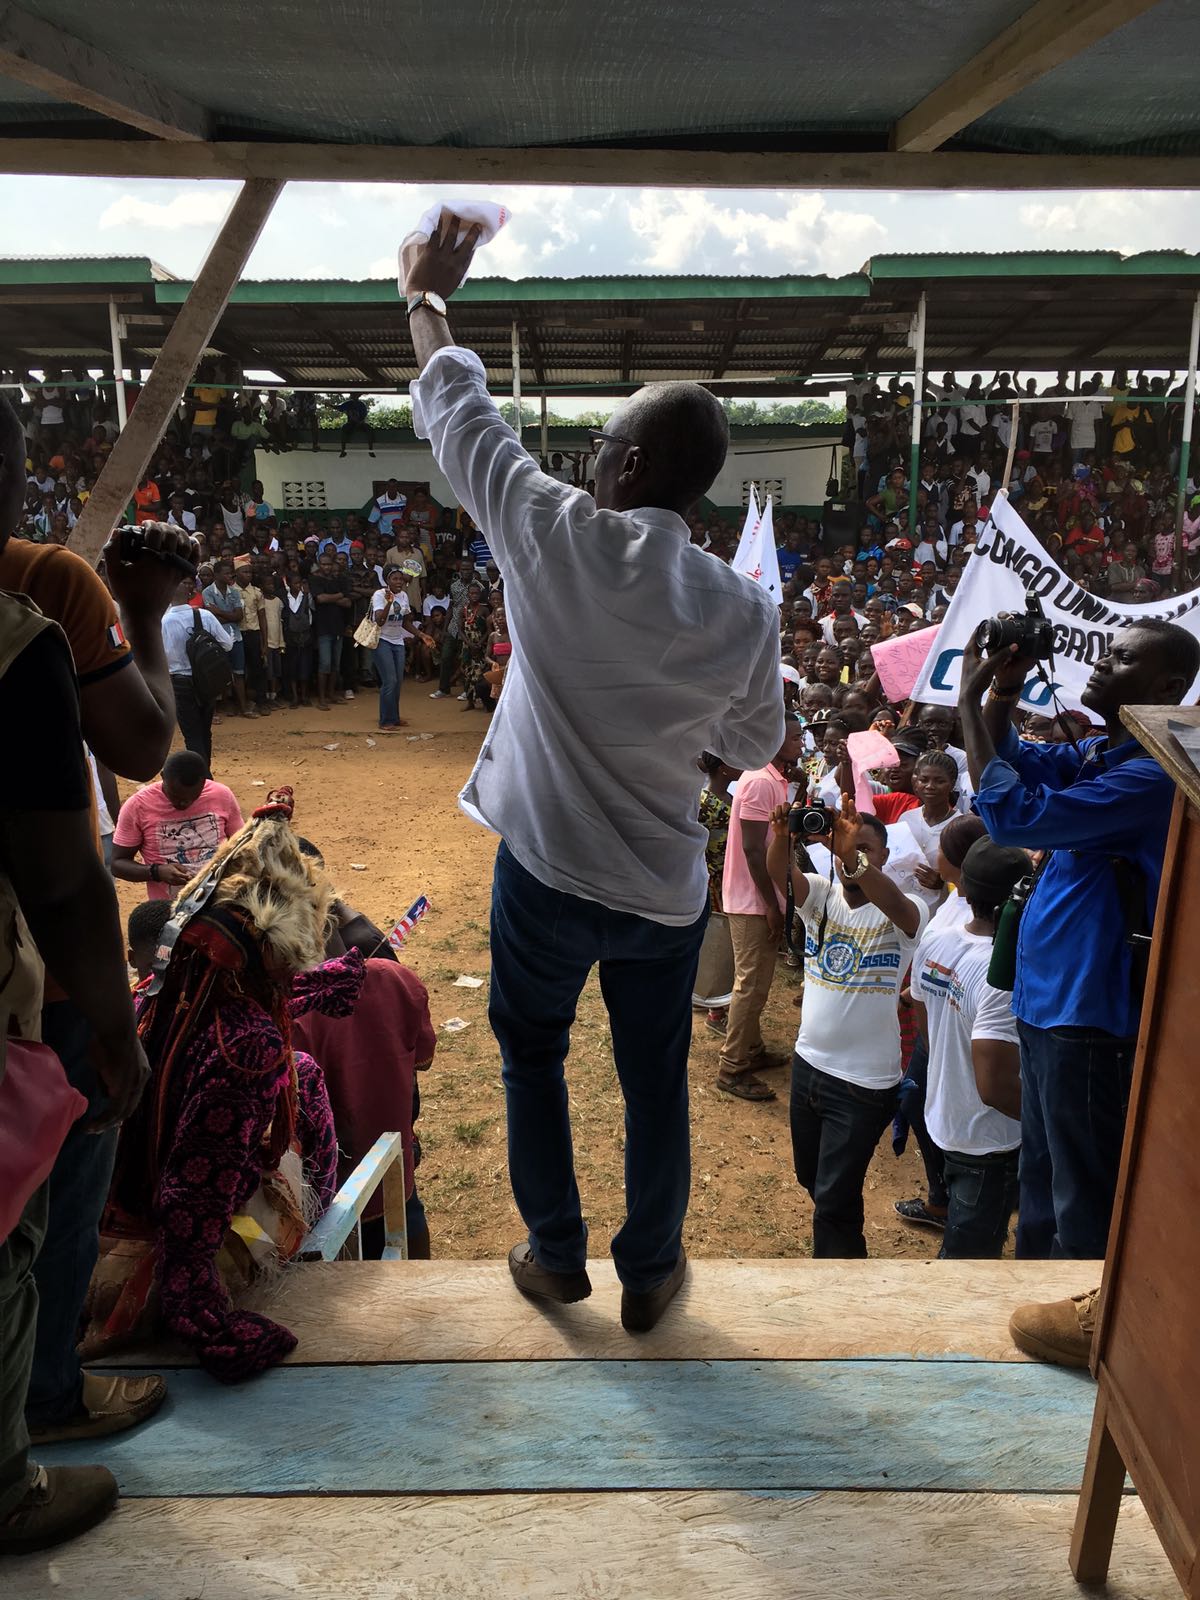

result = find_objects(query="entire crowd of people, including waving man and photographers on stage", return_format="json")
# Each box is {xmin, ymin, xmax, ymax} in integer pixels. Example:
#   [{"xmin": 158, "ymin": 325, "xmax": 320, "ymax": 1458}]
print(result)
[{"xmin": 0, "ymin": 219, "xmax": 1200, "ymax": 1550}]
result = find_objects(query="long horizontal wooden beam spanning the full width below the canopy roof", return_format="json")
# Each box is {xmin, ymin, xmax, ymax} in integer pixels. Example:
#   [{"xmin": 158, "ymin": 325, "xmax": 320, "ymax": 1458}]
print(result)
[{"xmin": 0, "ymin": 138, "xmax": 1200, "ymax": 189}]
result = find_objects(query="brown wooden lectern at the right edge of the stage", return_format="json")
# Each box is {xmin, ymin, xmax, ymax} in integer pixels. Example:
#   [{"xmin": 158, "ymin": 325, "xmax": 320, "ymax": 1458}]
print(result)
[{"xmin": 1070, "ymin": 706, "xmax": 1200, "ymax": 1600}]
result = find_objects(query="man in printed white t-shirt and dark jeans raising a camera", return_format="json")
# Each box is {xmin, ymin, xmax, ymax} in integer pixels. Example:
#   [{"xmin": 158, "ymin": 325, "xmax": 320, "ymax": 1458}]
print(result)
[{"xmin": 768, "ymin": 794, "xmax": 930, "ymax": 1259}]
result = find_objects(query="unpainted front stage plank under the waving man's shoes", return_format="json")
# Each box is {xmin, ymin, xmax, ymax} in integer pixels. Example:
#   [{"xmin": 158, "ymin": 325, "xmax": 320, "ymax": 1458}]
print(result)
[{"xmin": 96, "ymin": 1259, "xmax": 1101, "ymax": 1366}]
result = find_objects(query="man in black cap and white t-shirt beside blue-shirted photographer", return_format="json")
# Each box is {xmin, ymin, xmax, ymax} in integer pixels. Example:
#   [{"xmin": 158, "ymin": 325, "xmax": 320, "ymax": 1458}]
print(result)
[{"xmin": 912, "ymin": 838, "xmax": 1029, "ymax": 1261}]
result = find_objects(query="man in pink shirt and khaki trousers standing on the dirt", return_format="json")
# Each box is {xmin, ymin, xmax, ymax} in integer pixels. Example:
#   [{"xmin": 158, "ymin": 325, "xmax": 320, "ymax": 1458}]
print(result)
[{"xmin": 717, "ymin": 717, "xmax": 803, "ymax": 1101}]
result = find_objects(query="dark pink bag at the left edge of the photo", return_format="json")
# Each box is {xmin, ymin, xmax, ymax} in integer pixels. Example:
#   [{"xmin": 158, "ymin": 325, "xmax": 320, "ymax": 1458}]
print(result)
[{"xmin": 0, "ymin": 1038, "xmax": 88, "ymax": 1243}]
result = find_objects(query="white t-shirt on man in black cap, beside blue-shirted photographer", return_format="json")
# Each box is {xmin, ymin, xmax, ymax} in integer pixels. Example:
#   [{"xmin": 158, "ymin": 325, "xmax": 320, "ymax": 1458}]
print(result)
[{"xmin": 912, "ymin": 928, "xmax": 1021, "ymax": 1155}]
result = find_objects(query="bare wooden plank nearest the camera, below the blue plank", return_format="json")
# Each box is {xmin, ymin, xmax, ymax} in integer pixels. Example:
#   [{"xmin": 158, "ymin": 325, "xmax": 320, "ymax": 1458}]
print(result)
[{"xmin": 3, "ymin": 1491, "xmax": 1179, "ymax": 1600}]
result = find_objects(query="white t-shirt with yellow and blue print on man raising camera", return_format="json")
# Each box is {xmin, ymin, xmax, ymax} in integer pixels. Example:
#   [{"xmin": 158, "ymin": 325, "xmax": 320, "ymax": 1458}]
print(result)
[{"xmin": 795, "ymin": 872, "xmax": 930, "ymax": 1090}]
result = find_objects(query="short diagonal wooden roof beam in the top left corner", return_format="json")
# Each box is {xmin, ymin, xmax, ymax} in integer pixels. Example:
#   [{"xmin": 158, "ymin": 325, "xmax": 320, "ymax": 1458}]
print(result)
[{"xmin": 0, "ymin": 5, "xmax": 210, "ymax": 142}]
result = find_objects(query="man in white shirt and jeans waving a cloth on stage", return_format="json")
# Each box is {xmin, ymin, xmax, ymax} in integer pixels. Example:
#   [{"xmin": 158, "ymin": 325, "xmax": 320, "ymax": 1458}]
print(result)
[{"xmin": 403, "ymin": 218, "xmax": 784, "ymax": 1333}]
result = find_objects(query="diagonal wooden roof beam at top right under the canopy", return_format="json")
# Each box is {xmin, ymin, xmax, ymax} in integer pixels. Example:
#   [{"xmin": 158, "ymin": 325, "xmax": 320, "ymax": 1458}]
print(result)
[{"xmin": 891, "ymin": 0, "xmax": 1158, "ymax": 154}]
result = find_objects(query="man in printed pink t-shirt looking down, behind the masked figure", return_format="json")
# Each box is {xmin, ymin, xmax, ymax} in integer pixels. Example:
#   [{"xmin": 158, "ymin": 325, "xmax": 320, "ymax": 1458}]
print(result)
[{"xmin": 112, "ymin": 750, "xmax": 242, "ymax": 899}]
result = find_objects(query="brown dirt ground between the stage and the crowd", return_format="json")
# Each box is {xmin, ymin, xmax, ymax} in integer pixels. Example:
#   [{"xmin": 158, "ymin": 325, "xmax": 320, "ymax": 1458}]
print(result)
[{"xmin": 118, "ymin": 682, "xmax": 938, "ymax": 1259}]
